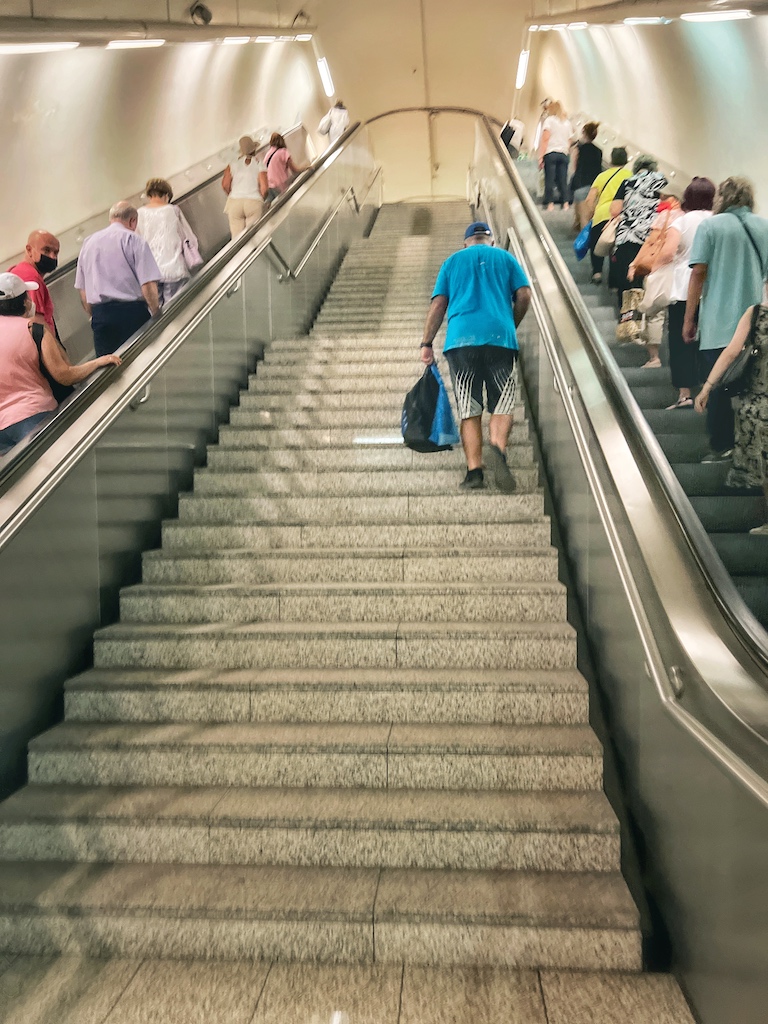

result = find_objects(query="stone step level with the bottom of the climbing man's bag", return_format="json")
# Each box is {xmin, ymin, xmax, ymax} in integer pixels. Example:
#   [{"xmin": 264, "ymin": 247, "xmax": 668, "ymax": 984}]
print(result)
[{"xmin": 208, "ymin": 442, "xmax": 534, "ymax": 468}]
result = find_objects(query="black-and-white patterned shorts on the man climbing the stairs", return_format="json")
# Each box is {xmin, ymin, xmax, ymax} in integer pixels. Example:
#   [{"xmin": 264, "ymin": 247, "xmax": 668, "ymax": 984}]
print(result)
[{"xmin": 445, "ymin": 345, "xmax": 517, "ymax": 420}]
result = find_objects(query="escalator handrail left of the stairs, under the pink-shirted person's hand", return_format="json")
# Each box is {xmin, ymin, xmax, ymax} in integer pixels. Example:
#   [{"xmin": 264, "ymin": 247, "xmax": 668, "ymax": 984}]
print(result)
[{"xmin": 0, "ymin": 122, "xmax": 360, "ymax": 496}]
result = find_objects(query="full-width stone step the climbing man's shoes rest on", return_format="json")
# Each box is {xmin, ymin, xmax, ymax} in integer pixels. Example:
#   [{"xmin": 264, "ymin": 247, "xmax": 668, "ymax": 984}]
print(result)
[{"xmin": 178, "ymin": 490, "xmax": 544, "ymax": 525}]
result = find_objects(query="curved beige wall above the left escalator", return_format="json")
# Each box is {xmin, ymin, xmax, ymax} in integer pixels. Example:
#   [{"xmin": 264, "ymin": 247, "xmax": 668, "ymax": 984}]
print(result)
[{"xmin": 0, "ymin": 43, "xmax": 327, "ymax": 254}]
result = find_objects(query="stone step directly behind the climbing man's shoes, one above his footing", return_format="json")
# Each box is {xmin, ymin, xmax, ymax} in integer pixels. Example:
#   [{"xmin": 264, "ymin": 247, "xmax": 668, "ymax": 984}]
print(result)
[{"xmin": 195, "ymin": 468, "xmax": 539, "ymax": 498}]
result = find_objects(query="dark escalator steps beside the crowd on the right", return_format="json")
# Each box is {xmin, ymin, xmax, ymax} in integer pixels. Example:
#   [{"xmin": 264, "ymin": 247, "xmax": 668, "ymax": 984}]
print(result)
[{"xmin": 545, "ymin": 214, "xmax": 768, "ymax": 628}]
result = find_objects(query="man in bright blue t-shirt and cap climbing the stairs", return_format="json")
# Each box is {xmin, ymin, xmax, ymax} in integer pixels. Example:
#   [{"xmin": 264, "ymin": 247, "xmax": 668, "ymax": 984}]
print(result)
[{"xmin": 421, "ymin": 221, "xmax": 530, "ymax": 494}]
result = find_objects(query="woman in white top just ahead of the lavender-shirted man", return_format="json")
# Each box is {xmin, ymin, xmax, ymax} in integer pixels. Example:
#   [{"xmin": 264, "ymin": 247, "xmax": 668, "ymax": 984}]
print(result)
[{"xmin": 136, "ymin": 178, "xmax": 203, "ymax": 305}]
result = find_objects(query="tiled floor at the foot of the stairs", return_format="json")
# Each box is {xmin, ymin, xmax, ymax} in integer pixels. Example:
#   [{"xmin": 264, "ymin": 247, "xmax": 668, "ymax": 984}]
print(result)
[{"xmin": 0, "ymin": 956, "xmax": 693, "ymax": 1024}]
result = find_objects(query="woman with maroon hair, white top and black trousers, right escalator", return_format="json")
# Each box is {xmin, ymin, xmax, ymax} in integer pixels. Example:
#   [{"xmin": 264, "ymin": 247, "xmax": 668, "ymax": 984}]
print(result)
[{"xmin": 668, "ymin": 178, "xmax": 715, "ymax": 409}]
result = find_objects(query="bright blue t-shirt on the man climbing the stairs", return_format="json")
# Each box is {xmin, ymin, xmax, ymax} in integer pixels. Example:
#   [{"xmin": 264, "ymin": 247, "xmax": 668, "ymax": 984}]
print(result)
[{"xmin": 432, "ymin": 244, "xmax": 528, "ymax": 352}]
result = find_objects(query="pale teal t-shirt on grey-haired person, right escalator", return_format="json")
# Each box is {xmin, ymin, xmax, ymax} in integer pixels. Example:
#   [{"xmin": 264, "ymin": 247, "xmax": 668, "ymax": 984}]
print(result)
[{"xmin": 688, "ymin": 206, "xmax": 768, "ymax": 350}]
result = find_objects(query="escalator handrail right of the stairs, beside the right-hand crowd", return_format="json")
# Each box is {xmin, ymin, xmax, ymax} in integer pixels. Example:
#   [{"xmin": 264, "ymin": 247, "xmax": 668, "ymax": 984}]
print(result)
[{"xmin": 483, "ymin": 119, "xmax": 768, "ymax": 672}]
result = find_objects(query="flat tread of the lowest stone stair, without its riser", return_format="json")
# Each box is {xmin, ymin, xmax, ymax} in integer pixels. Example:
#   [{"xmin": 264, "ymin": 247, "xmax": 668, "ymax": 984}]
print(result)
[{"xmin": 0, "ymin": 862, "xmax": 638, "ymax": 931}]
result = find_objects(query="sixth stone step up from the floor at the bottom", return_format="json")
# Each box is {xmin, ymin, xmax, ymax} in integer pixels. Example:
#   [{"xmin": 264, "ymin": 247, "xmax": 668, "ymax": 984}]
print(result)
[{"xmin": 120, "ymin": 581, "xmax": 565, "ymax": 625}]
